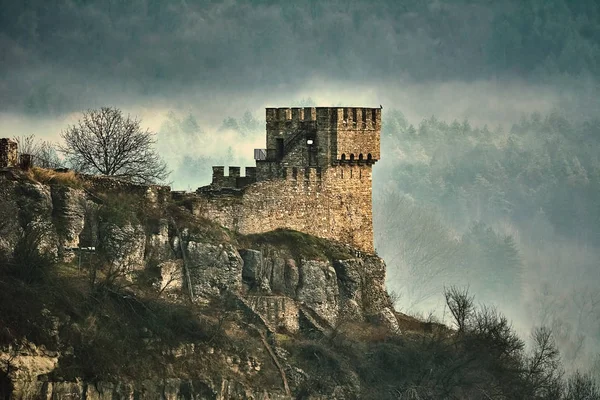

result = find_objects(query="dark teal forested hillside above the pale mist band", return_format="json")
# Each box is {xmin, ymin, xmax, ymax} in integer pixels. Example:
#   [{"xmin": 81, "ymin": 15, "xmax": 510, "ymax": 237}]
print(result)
[{"xmin": 0, "ymin": 0, "xmax": 600, "ymax": 114}]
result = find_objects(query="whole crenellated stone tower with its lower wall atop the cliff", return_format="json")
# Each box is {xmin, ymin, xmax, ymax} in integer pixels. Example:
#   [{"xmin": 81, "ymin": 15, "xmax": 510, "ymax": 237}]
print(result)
[{"xmin": 193, "ymin": 107, "xmax": 381, "ymax": 252}]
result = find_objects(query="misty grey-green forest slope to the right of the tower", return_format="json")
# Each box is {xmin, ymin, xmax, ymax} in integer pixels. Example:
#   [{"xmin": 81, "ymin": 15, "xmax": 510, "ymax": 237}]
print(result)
[{"xmin": 374, "ymin": 111, "xmax": 600, "ymax": 376}]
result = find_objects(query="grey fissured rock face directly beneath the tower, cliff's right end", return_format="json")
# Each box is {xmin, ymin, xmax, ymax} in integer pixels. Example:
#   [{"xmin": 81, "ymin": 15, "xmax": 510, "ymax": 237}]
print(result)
[{"xmin": 240, "ymin": 249, "xmax": 395, "ymax": 329}]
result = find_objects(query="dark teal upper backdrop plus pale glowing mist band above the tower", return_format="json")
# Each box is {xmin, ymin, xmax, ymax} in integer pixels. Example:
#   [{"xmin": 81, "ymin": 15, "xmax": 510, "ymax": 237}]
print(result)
[{"xmin": 0, "ymin": 0, "xmax": 600, "ymax": 180}]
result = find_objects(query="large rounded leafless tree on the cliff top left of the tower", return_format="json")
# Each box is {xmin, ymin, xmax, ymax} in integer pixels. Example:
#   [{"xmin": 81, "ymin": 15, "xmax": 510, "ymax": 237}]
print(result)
[{"xmin": 60, "ymin": 107, "xmax": 169, "ymax": 184}]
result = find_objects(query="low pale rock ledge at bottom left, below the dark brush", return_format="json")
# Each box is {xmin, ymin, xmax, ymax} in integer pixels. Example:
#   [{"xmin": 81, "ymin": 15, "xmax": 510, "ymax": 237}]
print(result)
[{"xmin": 0, "ymin": 342, "xmax": 291, "ymax": 400}]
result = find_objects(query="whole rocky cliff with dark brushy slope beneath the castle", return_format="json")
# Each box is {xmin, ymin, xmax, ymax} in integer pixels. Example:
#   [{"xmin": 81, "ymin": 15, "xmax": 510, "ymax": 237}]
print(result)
[{"xmin": 0, "ymin": 170, "xmax": 399, "ymax": 399}]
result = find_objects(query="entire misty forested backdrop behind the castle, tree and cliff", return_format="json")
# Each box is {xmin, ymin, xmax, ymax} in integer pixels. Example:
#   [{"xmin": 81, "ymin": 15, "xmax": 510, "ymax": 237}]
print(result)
[{"xmin": 0, "ymin": 0, "xmax": 600, "ymax": 375}]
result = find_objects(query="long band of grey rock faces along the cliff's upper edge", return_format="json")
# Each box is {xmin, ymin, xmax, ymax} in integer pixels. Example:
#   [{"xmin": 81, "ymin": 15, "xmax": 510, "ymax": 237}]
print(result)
[{"xmin": 0, "ymin": 180, "xmax": 395, "ymax": 330}]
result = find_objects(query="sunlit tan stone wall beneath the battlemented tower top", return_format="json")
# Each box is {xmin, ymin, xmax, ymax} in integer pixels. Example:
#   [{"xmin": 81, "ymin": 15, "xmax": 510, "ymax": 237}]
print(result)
[{"xmin": 193, "ymin": 163, "xmax": 373, "ymax": 253}]
